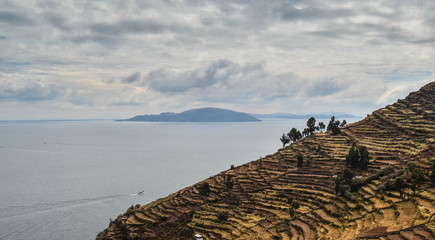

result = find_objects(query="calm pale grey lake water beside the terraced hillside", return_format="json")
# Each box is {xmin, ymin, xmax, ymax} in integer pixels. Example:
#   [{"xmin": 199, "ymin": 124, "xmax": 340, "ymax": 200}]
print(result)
[{"xmin": 0, "ymin": 120, "xmax": 354, "ymax": 240}]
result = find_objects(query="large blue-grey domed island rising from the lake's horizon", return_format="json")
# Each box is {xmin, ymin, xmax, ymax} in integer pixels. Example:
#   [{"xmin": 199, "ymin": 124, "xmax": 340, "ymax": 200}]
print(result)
[{"xmin": 119, "ymin": 108, "xmax": 261, "ymax": 122}]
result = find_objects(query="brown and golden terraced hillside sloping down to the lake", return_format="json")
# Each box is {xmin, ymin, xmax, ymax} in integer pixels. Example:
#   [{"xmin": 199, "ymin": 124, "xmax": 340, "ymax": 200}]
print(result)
[{"xmin": 97, "ymin": 82, "xmax": 435, "ymax": 239}]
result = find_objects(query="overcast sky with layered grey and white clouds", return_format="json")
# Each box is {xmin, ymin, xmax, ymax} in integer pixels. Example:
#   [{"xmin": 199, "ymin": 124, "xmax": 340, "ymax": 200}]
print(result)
[{"xmin": 0, "ymin": 0, "xmax": 435, "ymax": 120}]
